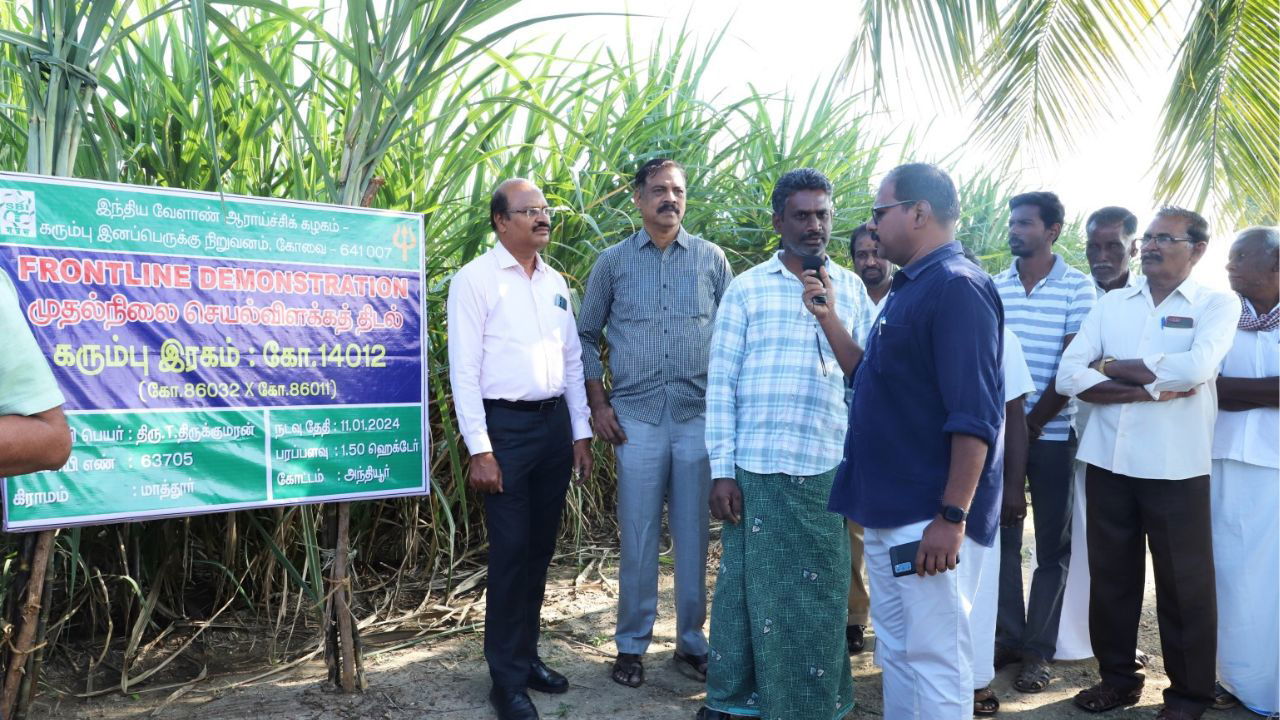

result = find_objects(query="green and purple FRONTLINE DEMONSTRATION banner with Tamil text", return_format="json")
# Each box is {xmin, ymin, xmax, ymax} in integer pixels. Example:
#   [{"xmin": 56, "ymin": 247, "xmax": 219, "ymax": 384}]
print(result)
[{"xmin": 0, "ymin": 173, "xmax": 429, "ymax": 530}]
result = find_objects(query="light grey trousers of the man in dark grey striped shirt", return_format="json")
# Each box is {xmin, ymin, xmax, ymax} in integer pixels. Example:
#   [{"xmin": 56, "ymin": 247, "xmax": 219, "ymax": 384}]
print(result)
[{"xmin": 613, "ymin": 410, "xmax": 712, "ymax": 655}]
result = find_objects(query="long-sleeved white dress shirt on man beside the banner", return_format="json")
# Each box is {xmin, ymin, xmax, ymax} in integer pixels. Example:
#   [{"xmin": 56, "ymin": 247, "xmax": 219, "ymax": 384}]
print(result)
[{"xmin": 448, "ymin": 242, "xmax": 591, "ymax": 455}]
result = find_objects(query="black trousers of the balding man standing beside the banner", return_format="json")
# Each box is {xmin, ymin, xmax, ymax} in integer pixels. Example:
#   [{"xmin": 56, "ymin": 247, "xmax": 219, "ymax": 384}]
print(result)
[{"xmin": 484, "ymin": 401, "xmax": 573, "ymax": 688}]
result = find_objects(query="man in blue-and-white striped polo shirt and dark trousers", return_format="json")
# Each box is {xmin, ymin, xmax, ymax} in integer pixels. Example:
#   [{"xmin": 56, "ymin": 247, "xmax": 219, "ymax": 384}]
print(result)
[{"xmin": 996, "ymin": 192, "xmax": 1096, "ymax": 693}]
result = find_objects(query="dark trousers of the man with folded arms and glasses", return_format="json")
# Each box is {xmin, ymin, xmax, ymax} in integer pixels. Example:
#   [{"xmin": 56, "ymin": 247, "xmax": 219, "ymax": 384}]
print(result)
[{"xmin": 1085, "ymin": 466, "xmax": 1217, "ymax": 715}]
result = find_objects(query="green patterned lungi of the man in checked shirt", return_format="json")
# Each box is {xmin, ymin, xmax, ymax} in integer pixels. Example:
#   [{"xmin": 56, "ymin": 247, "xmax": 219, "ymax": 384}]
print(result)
[{"xmin": 707, "ymin": 468, "xmax": 854, "ymax": 720}]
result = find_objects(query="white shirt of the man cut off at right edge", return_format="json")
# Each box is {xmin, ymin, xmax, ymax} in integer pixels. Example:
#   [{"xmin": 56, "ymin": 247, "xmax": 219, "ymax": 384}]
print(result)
[{"xmin": 1213, "ymin": 300, "xmax": 1280, "ymax": 468}]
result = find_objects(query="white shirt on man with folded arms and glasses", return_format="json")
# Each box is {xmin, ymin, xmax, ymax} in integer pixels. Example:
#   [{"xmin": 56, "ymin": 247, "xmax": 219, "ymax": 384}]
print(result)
[{"xmin": 1057, "ymin": 279, "xmax": 1240, "ymax": 480}]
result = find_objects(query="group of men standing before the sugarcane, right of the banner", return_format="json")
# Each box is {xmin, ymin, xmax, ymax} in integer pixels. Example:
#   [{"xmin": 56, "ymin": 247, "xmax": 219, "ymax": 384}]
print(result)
[{"xmin": 448, "ymin": 158, "xmax": 1280, "ymax": 720}]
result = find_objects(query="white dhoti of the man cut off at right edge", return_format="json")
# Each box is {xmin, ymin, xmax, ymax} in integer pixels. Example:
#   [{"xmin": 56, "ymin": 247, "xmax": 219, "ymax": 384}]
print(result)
[{"xmin": 1208, "ymin": 460, "xmax": 1280, "ymax": 716}]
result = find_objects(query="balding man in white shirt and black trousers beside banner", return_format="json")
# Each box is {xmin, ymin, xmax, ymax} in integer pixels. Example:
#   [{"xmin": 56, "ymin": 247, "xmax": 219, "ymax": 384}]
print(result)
[{"xmin": 448, "ymin": 178, "xmax": 591, "ymax": 720}]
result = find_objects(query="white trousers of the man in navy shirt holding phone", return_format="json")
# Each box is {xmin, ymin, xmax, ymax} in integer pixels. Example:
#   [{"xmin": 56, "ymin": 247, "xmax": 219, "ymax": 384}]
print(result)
[{"xmin": 863, "ymin": 521, "xmax": 998, "ymax": 720}]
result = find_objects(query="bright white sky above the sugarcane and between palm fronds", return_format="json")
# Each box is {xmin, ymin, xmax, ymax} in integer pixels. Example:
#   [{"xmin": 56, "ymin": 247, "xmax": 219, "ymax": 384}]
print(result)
[{"xmin": 481, "ymin": 0, "xmax": 1230, "ymax": 288}]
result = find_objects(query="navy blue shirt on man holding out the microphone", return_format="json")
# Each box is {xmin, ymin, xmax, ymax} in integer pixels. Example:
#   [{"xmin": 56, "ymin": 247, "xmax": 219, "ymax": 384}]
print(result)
[{"xmin": 828, "ymin": 242, "xmax": 1005, "ymax": 547}]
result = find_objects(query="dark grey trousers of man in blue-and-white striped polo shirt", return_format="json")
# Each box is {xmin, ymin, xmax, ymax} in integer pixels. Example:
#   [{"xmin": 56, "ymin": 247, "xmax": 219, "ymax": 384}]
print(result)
[{"xmin": 996, "ymin": 430, "xmax": 1076, "ymax": 660}]
